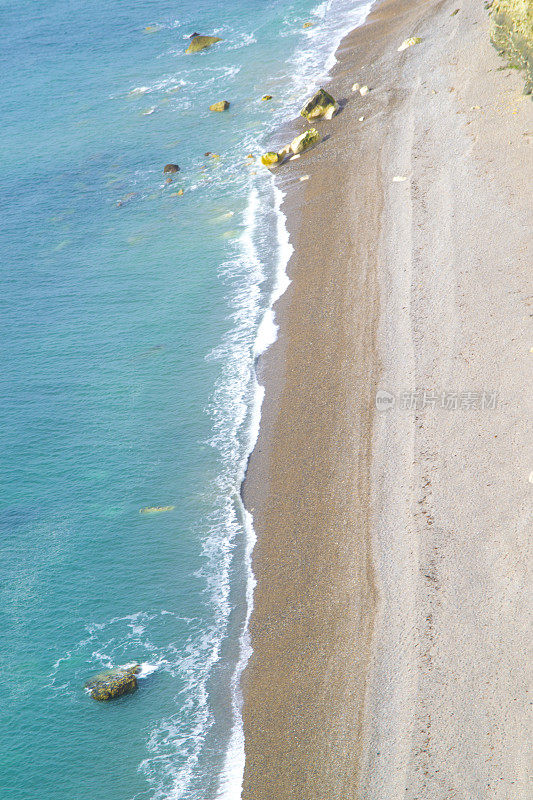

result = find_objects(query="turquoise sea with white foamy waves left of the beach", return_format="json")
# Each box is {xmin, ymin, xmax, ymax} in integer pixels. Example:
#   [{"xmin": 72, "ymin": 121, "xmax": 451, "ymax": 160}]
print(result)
[{"xmin": 0, "ymin": 0, "xmax": 370, "ymax": 800}]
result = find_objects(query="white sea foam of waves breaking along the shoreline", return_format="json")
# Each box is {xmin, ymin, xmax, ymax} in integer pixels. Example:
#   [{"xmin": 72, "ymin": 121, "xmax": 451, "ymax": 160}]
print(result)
[{"xmin": 93, "ymin": 0, "xmax": 371, "ymax": 800}]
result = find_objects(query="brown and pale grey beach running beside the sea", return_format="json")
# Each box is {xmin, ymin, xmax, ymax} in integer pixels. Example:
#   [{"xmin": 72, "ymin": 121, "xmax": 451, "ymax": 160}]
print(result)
[{"xmin": 242, "ymin": 0, "xmax": 533, "ymax": 800}]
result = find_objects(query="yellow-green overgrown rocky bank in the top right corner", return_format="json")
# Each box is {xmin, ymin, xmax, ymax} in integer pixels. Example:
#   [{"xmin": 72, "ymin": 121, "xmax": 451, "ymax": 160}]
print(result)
[{"xmin": 490, "ymin": 0, "xmax": 533, "ymax": 94}]
